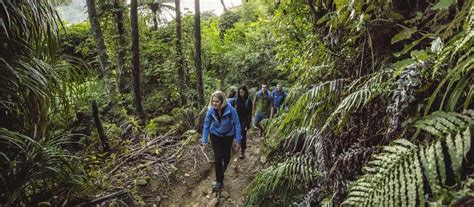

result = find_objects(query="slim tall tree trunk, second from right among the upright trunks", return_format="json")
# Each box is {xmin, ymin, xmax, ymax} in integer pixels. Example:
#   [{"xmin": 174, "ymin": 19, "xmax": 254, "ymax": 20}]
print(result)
[{"xmin": 174, "ymin": 0, "xmax": 187, "ymax": 105}]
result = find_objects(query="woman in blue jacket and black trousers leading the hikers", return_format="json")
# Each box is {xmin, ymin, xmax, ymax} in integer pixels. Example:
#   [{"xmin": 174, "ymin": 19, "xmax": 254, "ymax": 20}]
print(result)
[{"xmin": 202, "ymin": 91, "xmax": 242, "ymax": 192}]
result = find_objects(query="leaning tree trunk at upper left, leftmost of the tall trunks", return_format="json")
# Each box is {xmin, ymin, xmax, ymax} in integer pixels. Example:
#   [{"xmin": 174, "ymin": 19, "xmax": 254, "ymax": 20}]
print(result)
[{"xmin": 86, "ymin": 0, "xmax": 109, "ymax": 79}]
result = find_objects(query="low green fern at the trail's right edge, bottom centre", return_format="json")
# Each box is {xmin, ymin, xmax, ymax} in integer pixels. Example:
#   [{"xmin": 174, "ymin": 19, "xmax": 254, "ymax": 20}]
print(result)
[{"xmin": 244, "ymin": 156, "xmax": 322, "ymax": 206}]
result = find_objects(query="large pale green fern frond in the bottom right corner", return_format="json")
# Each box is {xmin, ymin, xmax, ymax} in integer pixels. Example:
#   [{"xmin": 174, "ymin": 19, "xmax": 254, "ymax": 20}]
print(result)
[{"xmin": 343, "ymin": 112, "xmax": 473, "ymax": 206}]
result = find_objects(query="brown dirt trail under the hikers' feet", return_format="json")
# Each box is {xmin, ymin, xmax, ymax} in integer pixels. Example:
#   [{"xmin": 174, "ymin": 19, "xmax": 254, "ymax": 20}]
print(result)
[{"xmin": 160, "ymin": 131, "xmax": 262, "ymax": 206}]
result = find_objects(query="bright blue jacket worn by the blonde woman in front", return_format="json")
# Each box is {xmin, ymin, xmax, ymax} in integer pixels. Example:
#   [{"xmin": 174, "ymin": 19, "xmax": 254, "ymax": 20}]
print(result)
[{"xmin": 202, "ymin": 104, "xmax": 242, "ymax": 144}]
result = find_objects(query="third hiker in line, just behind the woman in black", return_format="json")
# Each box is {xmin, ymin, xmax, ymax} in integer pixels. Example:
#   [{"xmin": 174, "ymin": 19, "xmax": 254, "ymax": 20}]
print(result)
[{"xmin": 253, "ymin": 83, "xmax": 274, "ymax": 137}]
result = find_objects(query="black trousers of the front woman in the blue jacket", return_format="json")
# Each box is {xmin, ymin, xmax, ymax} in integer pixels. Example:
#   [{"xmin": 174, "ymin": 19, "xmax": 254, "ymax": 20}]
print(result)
[{"xmin": 211, "ymin": 134, "xmax": 234, "ymax": 183}]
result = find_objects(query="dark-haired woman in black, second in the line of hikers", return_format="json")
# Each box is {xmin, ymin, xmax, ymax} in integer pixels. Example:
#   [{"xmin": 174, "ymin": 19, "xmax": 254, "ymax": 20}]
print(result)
[{"xmin": 234, "ymin": 85, "xmax": 252, "ymax": 159}]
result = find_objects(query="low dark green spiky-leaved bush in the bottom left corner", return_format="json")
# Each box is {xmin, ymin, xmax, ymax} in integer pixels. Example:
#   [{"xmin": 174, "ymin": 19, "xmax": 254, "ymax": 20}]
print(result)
[{"xmin": 0, "ymin": 128, "xmax": 83, "ymax": 205}]
